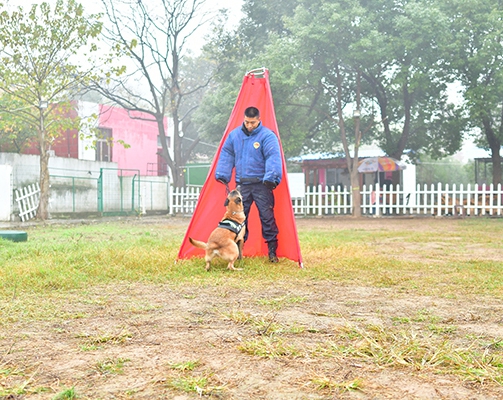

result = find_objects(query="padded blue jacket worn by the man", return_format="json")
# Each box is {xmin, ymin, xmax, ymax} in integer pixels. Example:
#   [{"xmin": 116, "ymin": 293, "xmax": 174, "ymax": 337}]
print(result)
[{"xmin": 215, "ymin": 123, "xmax": 283, "ymax": 184}]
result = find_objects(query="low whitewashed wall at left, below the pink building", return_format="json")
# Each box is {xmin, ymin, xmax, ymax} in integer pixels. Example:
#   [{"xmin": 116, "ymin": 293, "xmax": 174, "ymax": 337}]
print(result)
[{"xmin": 0, "ymin": 153, "xmax": 169, "ymax": 221}]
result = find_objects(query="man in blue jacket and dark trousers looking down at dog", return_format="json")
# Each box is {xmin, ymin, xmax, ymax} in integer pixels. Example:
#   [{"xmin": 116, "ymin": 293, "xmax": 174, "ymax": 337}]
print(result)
[{"xmin": 215, "ymin": 107, "xmax": 283, "ymax": 263}]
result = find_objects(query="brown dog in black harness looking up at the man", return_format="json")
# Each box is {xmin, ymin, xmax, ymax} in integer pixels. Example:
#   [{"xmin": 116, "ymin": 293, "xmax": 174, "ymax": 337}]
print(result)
[{"xmin": 189, "ymin": 190, "xmax": 246, "ymax": 271}]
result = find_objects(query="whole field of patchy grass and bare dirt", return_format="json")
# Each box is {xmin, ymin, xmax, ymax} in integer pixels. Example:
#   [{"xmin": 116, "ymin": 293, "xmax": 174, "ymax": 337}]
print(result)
[{"xmin": 0, "ymin": 217, "xmax": 503, "ymax": 399}]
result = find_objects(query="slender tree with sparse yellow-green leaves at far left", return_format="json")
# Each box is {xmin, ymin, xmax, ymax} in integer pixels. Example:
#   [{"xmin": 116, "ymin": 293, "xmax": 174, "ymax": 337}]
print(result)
[{"xmin": 0, "ymin": 0, "xmax": 101, "ymax": 220}]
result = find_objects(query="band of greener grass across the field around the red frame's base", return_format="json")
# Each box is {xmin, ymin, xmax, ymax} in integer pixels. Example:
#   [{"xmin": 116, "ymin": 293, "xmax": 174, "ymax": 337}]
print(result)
[{"xmin": 0, "ymin": 219, "xmax": 503, "ymax": 296}]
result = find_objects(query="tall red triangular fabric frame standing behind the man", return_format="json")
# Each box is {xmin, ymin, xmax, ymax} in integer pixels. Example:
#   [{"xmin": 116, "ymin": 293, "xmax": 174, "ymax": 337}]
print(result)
[{"xmin": 178, "ymin": 68, "xmax": 302, "ymax": 267}]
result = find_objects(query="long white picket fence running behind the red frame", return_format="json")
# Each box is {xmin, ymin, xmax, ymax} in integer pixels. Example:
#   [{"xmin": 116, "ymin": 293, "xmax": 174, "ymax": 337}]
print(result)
[{"xmin": 170, "ymin": 184, "xmax": 503, "ymax": 216}]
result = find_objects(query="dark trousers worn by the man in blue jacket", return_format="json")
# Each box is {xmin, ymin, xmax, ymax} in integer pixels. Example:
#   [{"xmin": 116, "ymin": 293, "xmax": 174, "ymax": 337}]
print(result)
[{"xmin": 239, "ymin": 183, "xmax": 279, "ymax": 242}]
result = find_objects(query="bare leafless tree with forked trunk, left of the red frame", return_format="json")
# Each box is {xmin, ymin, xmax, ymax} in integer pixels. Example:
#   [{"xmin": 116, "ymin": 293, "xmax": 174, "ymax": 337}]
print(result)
[{"xmin": 92, "ymin": 0, "xmax": 213, "ymax": 186}]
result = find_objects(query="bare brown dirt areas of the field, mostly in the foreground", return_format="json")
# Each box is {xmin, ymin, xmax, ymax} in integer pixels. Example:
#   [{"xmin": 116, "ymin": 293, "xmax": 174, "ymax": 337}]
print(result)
[{"xmin": 0, "ymin": 218, "xmax": 503, "ymax": 400}]
